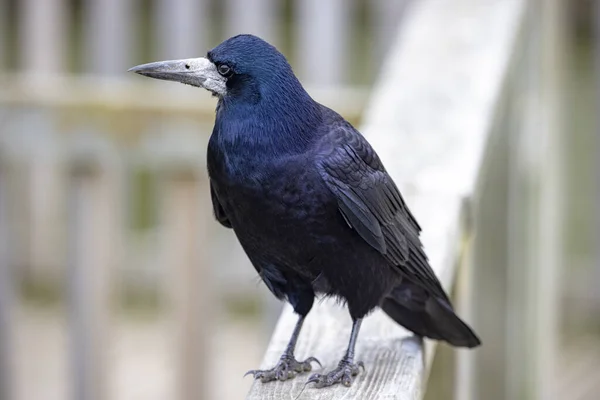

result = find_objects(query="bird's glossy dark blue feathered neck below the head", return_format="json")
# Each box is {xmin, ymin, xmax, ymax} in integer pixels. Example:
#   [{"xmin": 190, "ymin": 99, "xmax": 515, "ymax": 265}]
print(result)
[{"xmin": 215, "ymin": 89, "xmax": 323, "ymax": 157}]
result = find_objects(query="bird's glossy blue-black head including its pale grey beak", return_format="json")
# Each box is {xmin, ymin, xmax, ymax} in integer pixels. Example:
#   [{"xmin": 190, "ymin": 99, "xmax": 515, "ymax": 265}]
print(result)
[{"xmin": 129, "ymin": 35, "xmax": 304, "ymax": 102}]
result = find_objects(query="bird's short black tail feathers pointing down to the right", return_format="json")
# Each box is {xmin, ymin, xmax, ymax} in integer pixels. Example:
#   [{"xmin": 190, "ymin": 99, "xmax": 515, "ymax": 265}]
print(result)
[{"xmin": 381, "ymin": 282, "xmax": 481, "ymax": 347}]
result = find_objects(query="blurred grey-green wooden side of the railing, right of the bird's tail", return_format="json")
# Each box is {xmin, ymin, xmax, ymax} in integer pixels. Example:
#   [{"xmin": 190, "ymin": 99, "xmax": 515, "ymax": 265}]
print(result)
[{"xmin": 466, "ymin": 0, "xmax": 565, "ymax": 400}]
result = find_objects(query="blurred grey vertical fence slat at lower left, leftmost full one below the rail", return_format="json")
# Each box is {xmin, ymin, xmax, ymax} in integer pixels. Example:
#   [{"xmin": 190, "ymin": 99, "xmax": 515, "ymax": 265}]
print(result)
[{"xmin": 68, "ymin": 144, "xmax": 119, "ymax": 400}]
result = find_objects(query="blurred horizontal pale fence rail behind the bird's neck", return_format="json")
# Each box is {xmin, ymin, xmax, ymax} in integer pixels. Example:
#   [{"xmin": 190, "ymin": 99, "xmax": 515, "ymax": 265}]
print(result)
[{"xmin": 0, "ymin": 74, "xmax": 367, "ymax": 124}]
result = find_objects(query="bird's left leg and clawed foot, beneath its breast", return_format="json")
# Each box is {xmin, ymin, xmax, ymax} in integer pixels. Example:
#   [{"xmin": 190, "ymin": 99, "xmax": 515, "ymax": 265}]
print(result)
[{"xmin": 246, "ymin": 316, "xmax": 321, "ymax": 383}]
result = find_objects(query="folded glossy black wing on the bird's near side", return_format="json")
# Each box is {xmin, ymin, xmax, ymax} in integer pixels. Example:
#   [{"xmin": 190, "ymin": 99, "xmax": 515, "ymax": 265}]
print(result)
[{"xmin": 317, "ymin": 126, "xmax": 447, "ymax": 299}]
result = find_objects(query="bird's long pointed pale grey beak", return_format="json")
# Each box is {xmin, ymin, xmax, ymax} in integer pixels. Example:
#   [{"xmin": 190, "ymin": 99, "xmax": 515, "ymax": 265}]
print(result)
[{"xmin": 128, "ymin": 57, "xmax": 227, "ymax": 97}]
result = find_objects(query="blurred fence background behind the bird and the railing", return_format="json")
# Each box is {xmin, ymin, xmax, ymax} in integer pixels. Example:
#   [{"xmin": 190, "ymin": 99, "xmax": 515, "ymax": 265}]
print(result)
[{"xmin": 0, "ymin": 0, "xmax": 600, "ymax": 400}]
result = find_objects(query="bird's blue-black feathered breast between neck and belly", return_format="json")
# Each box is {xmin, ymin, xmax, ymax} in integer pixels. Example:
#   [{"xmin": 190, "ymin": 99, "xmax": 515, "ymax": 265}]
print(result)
[{"xmin": 208, "ymin": 131, "xmax": 338, "ymax": 264}]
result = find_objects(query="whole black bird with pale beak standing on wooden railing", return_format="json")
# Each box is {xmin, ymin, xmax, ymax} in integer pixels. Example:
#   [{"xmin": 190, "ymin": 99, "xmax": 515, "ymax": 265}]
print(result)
[{"xmin": 130, "ymin": 35, "xmax": 480, "ymax": 387}]
